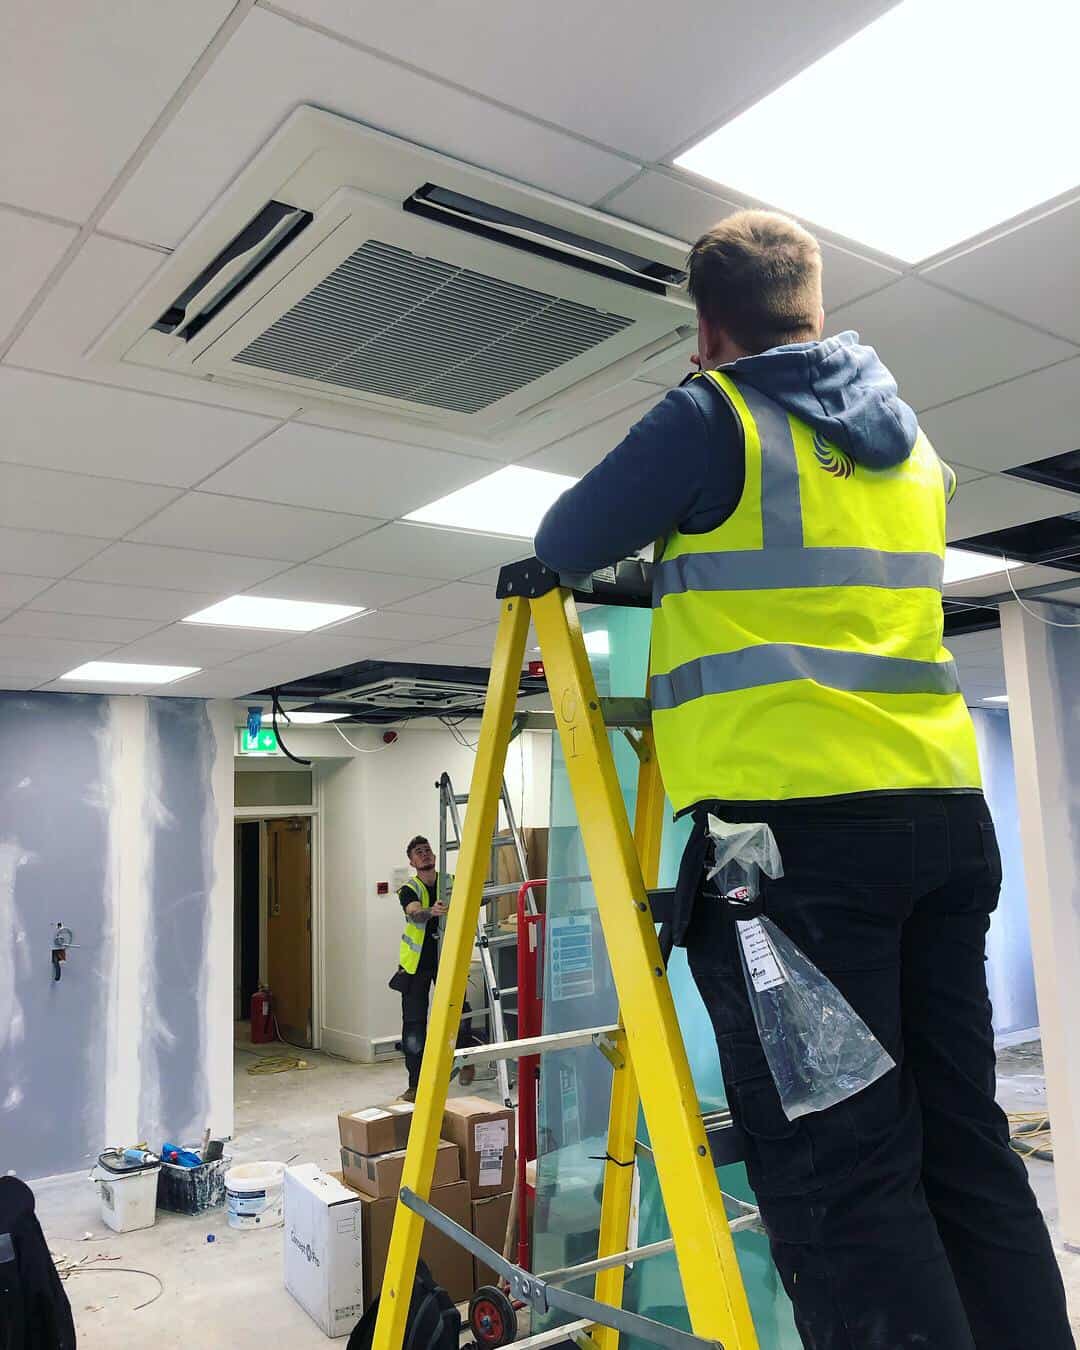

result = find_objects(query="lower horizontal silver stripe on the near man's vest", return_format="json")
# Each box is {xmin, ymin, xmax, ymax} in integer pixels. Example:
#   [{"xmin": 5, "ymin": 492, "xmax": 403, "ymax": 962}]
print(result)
[{"xmin": 649, "ymin": 643, "xmax": 960, "ymax": 711}]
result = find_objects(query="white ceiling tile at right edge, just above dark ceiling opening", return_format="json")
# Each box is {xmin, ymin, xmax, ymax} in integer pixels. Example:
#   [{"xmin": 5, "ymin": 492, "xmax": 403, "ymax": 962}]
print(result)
[{"xmin": 919, "ymin": 359, "xmax": 1080, "ymax": 471}]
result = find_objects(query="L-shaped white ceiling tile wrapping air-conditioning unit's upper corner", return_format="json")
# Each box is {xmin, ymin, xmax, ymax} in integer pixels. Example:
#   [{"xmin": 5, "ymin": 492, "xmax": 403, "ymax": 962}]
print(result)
[{"xmin": 104, "ymin": 8, "xmax": 636, "ymax": 246}]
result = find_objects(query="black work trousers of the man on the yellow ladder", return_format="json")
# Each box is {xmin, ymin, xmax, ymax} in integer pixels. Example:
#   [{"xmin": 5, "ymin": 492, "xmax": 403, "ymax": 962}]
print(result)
[{"xmin": 686, "ymin": 792, "xmax": 1075, "ymax": 1350}]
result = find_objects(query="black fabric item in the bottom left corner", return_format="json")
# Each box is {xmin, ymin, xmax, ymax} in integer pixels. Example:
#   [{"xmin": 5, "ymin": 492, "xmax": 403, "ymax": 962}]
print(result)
[{"xmin": 0, "ymin": 1177, "xmax": 76, "ymax": 1350}]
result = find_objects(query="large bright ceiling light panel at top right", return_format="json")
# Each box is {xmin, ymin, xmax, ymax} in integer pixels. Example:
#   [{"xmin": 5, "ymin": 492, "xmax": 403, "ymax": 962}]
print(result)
[{"xmin": 675, "ymin": 0, "xmax": 1080, "ymax": 262}]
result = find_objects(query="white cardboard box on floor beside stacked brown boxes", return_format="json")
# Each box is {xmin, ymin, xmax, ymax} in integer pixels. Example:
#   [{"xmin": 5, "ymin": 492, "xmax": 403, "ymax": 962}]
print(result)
[{"xmin": 285, "ymin": 1162, "xmax": 363, "ymax": 1337}]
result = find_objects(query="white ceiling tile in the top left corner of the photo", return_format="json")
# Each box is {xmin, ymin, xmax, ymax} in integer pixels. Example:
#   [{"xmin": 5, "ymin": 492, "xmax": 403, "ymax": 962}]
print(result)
[{"xmin": 0, "ymin": 0, "xmax": 232, "ymax": 221}]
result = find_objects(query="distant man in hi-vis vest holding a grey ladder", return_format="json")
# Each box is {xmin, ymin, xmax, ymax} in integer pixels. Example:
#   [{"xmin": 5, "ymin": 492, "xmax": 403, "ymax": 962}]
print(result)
[{"xmin": 390, "ymin": 834, "xmax": 467, "ymax": 1102}]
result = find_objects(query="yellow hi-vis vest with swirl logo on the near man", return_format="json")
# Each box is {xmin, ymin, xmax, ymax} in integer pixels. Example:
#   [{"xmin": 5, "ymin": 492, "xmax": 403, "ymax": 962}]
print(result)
[{"xmin": 649, "ymin": 370, "xmax": 980, "ymax": 811}]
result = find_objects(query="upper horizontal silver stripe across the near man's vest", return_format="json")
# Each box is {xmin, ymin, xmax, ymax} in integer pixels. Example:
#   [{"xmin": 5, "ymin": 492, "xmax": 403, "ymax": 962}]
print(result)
[{"xmin": 652, "ymin": 548, "xmax": 945, "ymax": 606}]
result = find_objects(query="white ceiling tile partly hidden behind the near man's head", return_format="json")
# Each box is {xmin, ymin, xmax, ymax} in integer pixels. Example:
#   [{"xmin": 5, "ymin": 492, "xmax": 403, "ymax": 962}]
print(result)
[{"xmin": 603, "ymin": 169, "xmax": 899, "ymax": 309}]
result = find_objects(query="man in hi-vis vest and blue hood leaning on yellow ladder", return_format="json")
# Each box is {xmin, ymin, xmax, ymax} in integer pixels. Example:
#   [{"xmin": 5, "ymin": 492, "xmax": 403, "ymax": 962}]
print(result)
[{"xmin": 536, "ymin": 208, "xmax": 1073, "ymax": 1350}]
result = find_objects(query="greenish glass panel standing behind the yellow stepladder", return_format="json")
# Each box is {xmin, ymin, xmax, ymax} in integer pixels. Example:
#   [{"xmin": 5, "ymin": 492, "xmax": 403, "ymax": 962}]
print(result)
[{"xmin": 533, "ymin": 606, "xmax": 801, "ymax": 1350}]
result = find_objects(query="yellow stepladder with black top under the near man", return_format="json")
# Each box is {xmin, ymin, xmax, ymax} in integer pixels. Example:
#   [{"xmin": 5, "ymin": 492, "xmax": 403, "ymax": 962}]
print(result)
[{"xmin": 373, "ymin": 559, "xmax": 757, "ymax": 1350}]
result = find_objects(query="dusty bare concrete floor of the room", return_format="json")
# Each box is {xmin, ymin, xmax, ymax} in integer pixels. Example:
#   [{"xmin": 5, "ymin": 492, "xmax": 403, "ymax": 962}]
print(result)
[{"xmin": 35, "ymin": 1031, "xmax": 1080, "ymax": 1350}]
